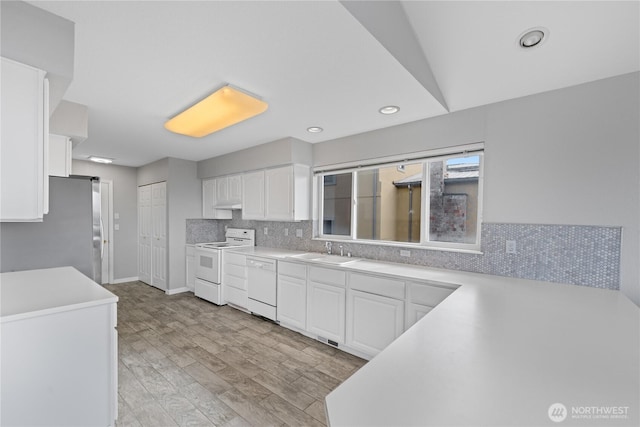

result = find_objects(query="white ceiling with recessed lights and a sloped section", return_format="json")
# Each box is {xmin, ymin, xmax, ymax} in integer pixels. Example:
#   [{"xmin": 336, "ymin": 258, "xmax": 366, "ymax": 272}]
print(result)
[{"xmin": 29, "ymin": 1, "xmax": 640, "ymax": 166}]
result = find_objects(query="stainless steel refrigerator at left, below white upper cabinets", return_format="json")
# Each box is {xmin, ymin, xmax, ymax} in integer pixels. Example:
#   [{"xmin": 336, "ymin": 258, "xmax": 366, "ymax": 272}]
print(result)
[{"xmin": 0, "ymin": 175, "xmax": 103, "ymax": 283}]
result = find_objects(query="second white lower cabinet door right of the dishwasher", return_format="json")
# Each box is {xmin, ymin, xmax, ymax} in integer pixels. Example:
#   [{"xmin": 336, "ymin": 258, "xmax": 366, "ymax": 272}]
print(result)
[{"xmin": 307, "ymin": 281, "xmax": 345, "ymax": 344}]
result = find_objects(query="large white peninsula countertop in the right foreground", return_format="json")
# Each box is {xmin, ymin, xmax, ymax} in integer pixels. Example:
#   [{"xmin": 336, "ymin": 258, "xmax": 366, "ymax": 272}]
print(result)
[{"xmin": 326, "ymin": 273, "xmax": 640, "ymax": 426}]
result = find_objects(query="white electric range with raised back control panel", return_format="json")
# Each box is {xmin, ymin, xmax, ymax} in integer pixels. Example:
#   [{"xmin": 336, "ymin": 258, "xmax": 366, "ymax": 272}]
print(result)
[{"xmin": 194, "ymin": 228, "xmax": 256, "ymax": 305}]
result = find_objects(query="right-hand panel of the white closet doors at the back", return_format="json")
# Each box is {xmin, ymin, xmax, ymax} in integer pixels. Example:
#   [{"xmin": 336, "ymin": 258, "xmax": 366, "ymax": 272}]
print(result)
[{"xmin": 151, "ymin": 182, "xmax": 167, "ymax": 290}]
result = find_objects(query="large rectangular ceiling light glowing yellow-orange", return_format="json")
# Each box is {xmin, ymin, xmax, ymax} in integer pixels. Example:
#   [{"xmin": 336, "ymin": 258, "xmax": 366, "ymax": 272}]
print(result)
[{"xmin": 164, "ymin": 85, "xmax": 269, "ymax": 138}]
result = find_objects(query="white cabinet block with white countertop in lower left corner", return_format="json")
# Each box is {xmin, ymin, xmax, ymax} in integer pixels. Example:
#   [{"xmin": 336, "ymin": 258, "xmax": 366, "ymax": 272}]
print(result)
[{"xmin": 0, "ymin": 267, "xmax": 118, "ymax": 426}]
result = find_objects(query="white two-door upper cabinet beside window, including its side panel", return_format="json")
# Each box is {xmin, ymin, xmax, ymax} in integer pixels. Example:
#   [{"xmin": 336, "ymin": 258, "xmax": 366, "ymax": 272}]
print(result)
[{"xmin": 242, "ymin": 165, "xmax": 311, "ymax": 221}]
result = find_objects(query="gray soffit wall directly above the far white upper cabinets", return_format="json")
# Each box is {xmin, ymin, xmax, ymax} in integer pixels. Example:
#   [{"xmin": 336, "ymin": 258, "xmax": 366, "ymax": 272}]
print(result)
[{"xmin": 198, "ymin": 138, "xmax": 313, "ymax": 178}]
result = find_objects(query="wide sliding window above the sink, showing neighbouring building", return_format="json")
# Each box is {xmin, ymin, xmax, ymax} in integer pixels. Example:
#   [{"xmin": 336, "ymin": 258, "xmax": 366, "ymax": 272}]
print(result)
[{"xmin": 316, "ymin": 151, "xmax": 482, "ymax": 249}]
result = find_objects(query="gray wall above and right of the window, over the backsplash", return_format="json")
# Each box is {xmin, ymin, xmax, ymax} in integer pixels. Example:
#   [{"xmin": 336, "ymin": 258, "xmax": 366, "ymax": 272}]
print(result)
[{"xmin": 313, "ymin": 73, "xmax": 640, "ymax": 304}]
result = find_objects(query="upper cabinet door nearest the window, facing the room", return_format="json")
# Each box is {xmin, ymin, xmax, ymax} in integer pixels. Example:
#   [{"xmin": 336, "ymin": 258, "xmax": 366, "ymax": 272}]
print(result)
[{"xmin": 264, "ymin": 166, "xmax": 293, "ymax": 221}]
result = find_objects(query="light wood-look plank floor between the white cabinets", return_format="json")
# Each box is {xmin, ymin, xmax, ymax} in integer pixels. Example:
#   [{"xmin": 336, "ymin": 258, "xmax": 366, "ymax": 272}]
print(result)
[{"xmin": 106, "ymin": 282, "xmax": 366, "ymax": 427}]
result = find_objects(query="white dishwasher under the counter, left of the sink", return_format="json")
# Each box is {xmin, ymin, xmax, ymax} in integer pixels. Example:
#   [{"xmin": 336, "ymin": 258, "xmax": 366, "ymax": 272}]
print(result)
[{"xmin": 247, "ymin": 256, "xmax": 276, "ymax": 321}]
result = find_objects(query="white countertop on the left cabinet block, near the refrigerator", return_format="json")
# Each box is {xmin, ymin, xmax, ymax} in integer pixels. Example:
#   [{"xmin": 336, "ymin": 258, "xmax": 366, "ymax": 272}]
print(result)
[{"xmin": 0, "ymin": 267, "xmax": 118, "ymax": 323}]
